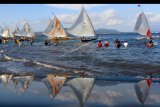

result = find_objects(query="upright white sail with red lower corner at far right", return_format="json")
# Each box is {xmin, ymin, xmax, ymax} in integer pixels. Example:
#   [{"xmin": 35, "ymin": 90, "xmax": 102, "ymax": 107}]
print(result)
[{"xmin": 134, "ymin": 12, "xmax": 151, "ymax": 38}]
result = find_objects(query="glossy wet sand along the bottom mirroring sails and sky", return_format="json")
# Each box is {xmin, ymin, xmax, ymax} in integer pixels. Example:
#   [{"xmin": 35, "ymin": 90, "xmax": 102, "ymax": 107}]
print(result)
[{"xmin": 0, "ymin": 74, "xmax": 160, "ymax": 107}]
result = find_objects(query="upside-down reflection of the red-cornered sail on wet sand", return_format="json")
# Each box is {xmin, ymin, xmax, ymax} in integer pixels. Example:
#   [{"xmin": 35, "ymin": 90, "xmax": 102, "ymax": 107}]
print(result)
[{"xmin": 135, "ymin": 79, "xmax": 151, "ymax": 104}]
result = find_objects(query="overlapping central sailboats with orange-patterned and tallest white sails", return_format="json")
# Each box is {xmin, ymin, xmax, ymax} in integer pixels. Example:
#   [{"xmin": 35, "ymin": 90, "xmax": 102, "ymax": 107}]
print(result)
[{"xmin": 43, "ymin": 7, "xmax": 97, "ymax": 42}]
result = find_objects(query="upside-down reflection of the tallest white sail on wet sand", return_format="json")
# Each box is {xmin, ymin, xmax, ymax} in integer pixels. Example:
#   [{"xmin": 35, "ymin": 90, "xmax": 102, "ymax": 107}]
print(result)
[{"xmin": 66, "ymin": 78, "xmax": 95, "ymax": 107}]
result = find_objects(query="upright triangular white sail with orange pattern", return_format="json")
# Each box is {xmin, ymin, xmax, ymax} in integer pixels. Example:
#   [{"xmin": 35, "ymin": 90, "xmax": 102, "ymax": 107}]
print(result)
[{"xmin": 50, "ymin": 16, "xmax": 68, "ymax": 39}]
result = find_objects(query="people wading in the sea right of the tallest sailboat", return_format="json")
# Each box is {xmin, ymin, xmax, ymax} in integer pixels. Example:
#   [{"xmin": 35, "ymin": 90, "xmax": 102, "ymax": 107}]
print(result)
[{"xmin": 97, "ymin": 39, "xmax": 154, "ymax": 48}]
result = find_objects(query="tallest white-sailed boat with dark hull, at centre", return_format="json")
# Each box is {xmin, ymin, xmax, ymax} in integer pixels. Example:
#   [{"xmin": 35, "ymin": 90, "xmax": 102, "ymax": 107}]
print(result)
[{"xmin": 67, "ymin": 6, "xmax": 97, "ymax": 42}]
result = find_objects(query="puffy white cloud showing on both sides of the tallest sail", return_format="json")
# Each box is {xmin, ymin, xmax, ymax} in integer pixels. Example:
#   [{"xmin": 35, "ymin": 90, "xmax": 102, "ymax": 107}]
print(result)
[{"xmin": 57, "ymin": 9, "xmax": 124, "ymax": 28}]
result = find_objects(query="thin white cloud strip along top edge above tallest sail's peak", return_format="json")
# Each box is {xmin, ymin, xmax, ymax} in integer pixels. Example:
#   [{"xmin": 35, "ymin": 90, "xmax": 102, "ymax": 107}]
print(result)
[{"xmin": 45, "ymin": 4, "xmax": 108, "ymax": 10}]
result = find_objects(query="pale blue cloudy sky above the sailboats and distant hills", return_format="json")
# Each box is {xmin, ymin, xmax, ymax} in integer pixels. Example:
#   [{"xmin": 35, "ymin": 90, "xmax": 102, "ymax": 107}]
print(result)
[{"xmin": 0, "ymin": 4, "xmax": 160, "ymax": 32}]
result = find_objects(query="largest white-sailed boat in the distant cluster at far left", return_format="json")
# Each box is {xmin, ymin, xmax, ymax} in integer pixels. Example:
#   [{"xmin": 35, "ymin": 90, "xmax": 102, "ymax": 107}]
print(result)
[{"xmin": 20, "ymin": 22, "xmax": 35, "ymax": 39}]
